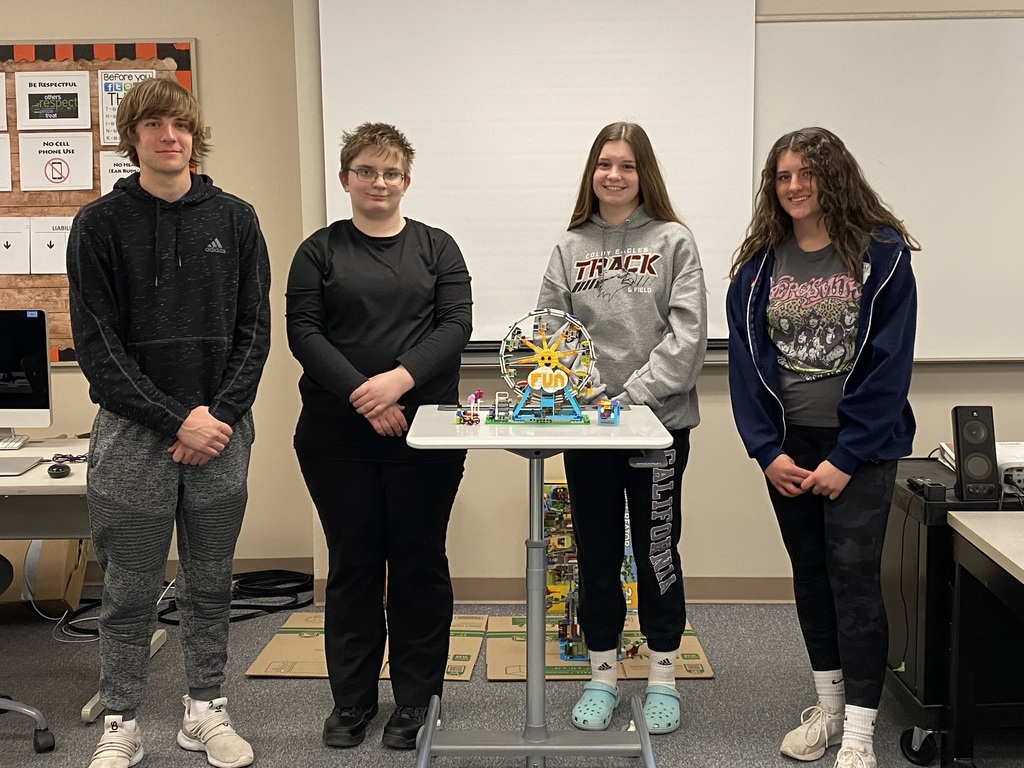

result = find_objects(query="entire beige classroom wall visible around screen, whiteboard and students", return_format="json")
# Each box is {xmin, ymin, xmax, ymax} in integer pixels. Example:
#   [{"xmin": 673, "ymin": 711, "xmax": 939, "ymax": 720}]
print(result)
[{"xmin": 8, "ymin": 0, "xmax": 1024, "ymax": 599}]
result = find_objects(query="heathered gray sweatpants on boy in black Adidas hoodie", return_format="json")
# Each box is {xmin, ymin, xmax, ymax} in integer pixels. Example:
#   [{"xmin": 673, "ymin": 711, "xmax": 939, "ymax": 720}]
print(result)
[{"xmin": 87, "ymin": 409, "xmax": 253, "ymax": 713}]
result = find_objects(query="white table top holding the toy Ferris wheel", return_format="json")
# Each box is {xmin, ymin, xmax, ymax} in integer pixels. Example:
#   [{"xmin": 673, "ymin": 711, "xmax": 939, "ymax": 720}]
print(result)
[{"xmin": 406, "ymin": 406, "xmax": 672, "ymax": 451}]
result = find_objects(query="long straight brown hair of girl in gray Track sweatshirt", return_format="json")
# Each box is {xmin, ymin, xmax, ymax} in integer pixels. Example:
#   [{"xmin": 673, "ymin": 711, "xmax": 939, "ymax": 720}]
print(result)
[{"xmin": 568, "ymin": 123, "xmax": 683, "ymax": 229}]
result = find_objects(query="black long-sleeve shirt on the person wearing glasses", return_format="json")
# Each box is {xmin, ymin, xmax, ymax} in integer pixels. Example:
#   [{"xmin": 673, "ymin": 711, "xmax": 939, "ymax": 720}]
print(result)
[{"xmin": 287, "ymin": 219, "xmax": 472, "ymax": 455}]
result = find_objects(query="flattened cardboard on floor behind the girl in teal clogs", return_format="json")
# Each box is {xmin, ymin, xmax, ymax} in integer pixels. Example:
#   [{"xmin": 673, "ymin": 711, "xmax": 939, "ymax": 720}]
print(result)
[{"xmin": 487, "ymin": 613, "xmax": 715, "ymax": 680}]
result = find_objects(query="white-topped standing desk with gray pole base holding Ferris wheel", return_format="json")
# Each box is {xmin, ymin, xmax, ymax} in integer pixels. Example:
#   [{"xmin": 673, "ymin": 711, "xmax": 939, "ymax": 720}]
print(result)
[{"xmin": 407, "ymin": 406, "xmax": 672, "ymax": 768}]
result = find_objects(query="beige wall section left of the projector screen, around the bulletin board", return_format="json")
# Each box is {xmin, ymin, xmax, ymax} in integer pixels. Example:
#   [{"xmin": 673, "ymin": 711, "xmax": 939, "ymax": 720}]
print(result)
[{"xmin": 7, "ymin": 0, "xmax": 318, "ymax": 581}]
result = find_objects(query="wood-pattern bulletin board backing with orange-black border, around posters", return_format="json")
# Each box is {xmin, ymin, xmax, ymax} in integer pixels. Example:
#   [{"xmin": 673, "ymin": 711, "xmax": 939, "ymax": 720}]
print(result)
[{"xmin": 0, "ymin": 41, "xmax": 195, "ymax": 359}]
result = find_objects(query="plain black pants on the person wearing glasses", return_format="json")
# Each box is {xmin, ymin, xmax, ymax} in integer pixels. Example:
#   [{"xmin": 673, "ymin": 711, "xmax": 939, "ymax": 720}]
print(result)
[{"xmin": 298, "ymin": 452, "xmax": 465, "ymax": 707}]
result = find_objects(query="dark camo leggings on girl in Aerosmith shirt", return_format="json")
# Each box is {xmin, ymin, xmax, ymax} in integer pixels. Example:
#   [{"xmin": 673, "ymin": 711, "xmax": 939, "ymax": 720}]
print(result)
[{"xmin": 768, "ymin": 426, "xmax": 896, "ymax": 710}]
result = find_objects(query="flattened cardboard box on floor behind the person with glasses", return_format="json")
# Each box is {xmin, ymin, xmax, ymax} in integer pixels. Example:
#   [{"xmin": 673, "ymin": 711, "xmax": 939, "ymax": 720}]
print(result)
[{"xmin": 246, "ymin": 613, "xmax": 487, "ymax": 680}]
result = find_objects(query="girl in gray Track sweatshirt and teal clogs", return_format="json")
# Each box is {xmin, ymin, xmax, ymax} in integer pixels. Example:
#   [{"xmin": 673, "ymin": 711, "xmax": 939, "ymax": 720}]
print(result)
[{"xmin": 538, "ymin": 123, "xmax": 708, "ymax": 733}]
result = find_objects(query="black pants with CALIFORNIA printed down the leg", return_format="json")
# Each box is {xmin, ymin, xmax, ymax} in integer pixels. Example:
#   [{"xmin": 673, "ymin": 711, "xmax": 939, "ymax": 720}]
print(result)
[{"xmin": 564, "ymin": 429, "xmax": 690, "ymax": 652}]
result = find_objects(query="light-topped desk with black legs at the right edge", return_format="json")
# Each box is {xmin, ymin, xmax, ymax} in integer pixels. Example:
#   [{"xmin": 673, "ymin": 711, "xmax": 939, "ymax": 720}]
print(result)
[{"xmin": 942, "ymin": 511, "xmax": 1024, "ymax": 768}]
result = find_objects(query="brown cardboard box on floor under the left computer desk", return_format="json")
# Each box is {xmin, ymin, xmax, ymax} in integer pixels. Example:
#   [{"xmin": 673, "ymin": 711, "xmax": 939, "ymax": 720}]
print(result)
[{"xmin": 0, "ymin": 539, "xmax": 89, "ymax": 612}]
